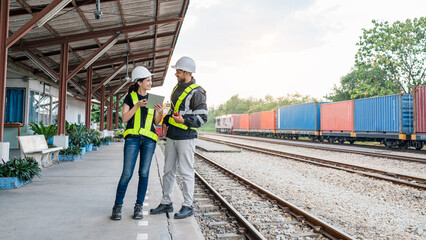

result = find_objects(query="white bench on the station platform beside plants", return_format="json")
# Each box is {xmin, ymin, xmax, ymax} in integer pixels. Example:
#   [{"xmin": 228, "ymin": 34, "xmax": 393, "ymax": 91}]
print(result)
[{"xmin": 18, "ymin": 135, "xmax": 63, "ymax": 167}]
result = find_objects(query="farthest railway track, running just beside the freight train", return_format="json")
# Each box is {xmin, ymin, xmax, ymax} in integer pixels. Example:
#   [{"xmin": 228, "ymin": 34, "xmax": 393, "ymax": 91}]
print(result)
[{"xmin": 205, "ymin": 133, "xmax": 426, "ymax": 164}]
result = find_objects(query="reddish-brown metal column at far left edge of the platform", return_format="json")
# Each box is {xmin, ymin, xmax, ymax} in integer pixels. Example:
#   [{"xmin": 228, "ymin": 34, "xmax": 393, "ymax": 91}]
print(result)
[{"xmin": 0, "ymin": 0, "xmax": 9, "ymax": 142}]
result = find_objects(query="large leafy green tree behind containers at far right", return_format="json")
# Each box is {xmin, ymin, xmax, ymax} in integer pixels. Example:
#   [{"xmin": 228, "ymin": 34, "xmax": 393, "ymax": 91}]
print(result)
[{"xmin": 329, "ymin": 17, "xmax": 426, "ymax": 101}]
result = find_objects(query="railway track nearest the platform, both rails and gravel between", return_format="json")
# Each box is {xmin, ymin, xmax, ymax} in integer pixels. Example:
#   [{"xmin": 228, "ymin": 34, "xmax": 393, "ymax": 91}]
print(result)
[{"xmin": 195, "ymin": 152, "xmax": 354, "ymax": 240}]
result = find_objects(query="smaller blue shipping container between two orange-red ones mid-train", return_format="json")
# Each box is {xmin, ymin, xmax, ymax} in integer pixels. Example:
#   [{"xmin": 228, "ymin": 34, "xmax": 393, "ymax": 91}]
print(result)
[{"xmin": 277, "ymin": 103, "xmax": 323, "ymax": 131}]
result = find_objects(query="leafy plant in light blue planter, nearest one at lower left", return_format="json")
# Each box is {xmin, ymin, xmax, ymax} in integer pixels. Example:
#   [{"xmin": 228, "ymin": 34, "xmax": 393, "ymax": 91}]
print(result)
[{"xmin": 0, "ymin": 157, "xmax": 41, "ymax": 189}]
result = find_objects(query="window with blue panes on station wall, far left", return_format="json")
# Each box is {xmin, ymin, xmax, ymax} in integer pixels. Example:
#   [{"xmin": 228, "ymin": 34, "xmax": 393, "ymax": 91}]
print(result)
[{"xmin": 4, "ymin": 88, "xmax": 25, "ymax": 123}]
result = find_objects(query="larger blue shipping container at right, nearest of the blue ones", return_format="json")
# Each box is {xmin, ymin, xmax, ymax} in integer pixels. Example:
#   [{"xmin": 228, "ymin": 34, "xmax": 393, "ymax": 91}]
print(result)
[{"xmin": 354, "ymin": 94, "xmax": 413, "ymax": 133}]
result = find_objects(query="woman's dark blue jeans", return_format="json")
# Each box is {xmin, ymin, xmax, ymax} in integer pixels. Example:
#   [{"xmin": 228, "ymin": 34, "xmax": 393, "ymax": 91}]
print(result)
[{"xmin": 115, "ymin": 136, "xmax": 157, "ymax": 205}]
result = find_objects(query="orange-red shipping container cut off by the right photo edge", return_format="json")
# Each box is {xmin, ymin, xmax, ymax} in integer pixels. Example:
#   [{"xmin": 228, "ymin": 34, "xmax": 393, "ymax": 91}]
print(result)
[{"xmin": 413, "ymin": 86, "xmax": 426, "ymax": 134}]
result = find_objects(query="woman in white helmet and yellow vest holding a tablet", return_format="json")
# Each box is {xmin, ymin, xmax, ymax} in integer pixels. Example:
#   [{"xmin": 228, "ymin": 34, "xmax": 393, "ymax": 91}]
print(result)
[{"xmin": 111, "ymin": 66, "xmax": 163, "ymax": 220}]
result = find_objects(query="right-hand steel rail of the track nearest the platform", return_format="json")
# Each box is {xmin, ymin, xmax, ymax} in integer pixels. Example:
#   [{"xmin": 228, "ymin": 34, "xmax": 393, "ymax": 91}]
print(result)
[{"xmin": 195, "ymin": 152, "xmax": 354, "ymax": 240}]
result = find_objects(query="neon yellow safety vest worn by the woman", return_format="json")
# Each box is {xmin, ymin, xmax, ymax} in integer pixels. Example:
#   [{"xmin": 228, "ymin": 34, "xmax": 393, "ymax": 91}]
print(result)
[{"xmin": 123, "ymin": 92, "xmax": 158, "ymax": 141}]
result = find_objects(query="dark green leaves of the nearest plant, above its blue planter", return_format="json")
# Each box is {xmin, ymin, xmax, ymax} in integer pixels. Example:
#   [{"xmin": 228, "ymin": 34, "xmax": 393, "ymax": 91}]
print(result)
[{"xmin": 0, "ymin": 157, "xmax": 41, "ymax": 182}]
